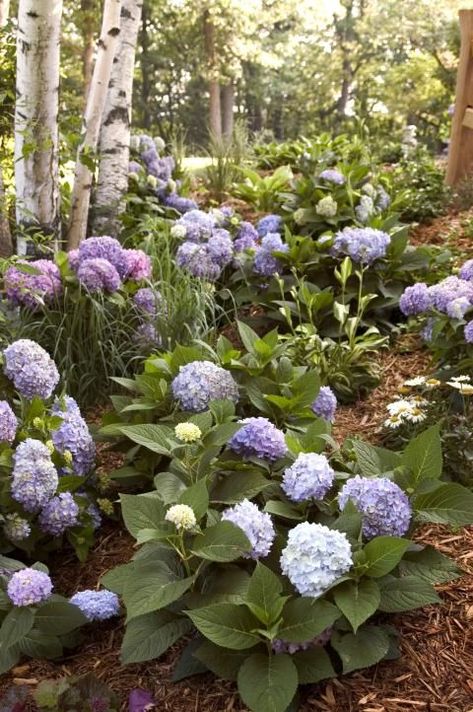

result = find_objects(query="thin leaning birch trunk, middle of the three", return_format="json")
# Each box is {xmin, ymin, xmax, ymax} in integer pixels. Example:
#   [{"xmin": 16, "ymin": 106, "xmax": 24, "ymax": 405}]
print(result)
[{"xmin": 67, "ymin": 0, "xmax": 121, "ymax": 250}]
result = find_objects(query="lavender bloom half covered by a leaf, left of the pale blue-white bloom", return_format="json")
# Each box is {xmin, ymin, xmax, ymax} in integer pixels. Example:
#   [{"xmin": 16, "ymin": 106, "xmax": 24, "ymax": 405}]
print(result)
[{"xmin": 222, "ymin": 499, "xmax": 276, "ymax": 559}]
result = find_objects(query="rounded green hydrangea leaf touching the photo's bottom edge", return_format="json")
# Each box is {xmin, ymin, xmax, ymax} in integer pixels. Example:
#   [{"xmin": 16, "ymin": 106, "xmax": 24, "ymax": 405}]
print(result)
[{"xmin": 238, "ymin": 653, "xmax": 298, "ymax": 712}]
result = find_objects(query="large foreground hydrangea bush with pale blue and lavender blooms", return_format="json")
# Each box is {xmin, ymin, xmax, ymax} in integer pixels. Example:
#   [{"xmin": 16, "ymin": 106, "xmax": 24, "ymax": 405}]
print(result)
[{"xmin": 103, "ymin": 412, "xmax": 473, "ymax": 712}]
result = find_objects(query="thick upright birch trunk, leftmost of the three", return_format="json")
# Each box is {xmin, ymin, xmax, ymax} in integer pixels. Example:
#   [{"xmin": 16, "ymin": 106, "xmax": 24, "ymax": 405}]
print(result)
[{"xmin": 15, "ymin": 0, "xmax": 62, "ymax": 254}]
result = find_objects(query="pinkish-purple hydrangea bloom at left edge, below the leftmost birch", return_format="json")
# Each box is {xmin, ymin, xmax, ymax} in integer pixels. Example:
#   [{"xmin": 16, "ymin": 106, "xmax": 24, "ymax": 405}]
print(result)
[{"xmin": 4, "ymin": 260, "xmax": 62, "ymax": 310}]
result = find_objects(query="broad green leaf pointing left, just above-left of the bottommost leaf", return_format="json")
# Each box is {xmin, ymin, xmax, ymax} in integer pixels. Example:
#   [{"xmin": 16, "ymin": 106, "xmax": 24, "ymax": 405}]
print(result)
[{"xmin": 187, "ymin": 603, "xmax": 260, "ymax": 650}]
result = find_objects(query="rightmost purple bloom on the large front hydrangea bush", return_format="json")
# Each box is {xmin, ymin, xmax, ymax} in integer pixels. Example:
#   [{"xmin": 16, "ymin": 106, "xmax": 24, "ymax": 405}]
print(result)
[{"xmin": 338, "ymin": 475, "xmax": 412, "ymax": 539}]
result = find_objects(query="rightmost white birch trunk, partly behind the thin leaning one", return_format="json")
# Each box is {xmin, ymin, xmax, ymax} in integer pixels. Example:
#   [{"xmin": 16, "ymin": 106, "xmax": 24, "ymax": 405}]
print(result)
[{"xmin": 92, "ymin": 0, "xmax": 143, "ymax": 235}]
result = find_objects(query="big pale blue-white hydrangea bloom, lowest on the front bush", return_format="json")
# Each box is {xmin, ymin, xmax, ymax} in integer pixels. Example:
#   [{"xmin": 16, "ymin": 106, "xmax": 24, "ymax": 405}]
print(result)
[{"xmin": 280, "ymin": 522, "xmax": 353, "ymax": 598}]
